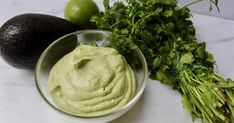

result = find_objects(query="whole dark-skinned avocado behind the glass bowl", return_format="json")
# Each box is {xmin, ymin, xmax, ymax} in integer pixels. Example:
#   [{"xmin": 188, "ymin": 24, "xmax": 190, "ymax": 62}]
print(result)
[{"xmin": 0, "ymin": 13, "xmax": 76, "ymax": 70}]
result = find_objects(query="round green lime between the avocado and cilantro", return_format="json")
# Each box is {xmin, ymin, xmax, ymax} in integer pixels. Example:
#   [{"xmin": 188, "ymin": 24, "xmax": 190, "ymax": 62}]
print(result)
[{"xmin": 64, "ymin": 0, "xmax": 99, "ymax": 29}]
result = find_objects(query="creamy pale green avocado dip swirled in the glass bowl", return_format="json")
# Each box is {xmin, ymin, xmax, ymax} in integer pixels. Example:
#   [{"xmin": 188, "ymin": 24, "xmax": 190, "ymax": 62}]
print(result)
[{"xmin": 48, "ymin": 45, "xmax": 136, "ymax": 117}]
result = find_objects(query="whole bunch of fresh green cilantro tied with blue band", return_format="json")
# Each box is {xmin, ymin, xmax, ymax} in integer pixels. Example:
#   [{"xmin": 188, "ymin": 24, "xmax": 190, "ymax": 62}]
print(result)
[{"xmin": 92, "ymin": 0, "xmax": 234, "ymax": 123}]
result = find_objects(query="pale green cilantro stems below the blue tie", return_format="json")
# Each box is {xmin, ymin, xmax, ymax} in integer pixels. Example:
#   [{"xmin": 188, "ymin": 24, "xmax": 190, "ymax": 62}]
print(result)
[{"xmin": 179, "ymin": 69, "xmax": 229, "ymax": 123}]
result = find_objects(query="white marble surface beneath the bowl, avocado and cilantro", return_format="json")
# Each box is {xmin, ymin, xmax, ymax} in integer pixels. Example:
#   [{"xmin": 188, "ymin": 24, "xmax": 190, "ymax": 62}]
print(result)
[{"xmin": 0, "ymin": 0, "xmax": 234, "ymax": 123}]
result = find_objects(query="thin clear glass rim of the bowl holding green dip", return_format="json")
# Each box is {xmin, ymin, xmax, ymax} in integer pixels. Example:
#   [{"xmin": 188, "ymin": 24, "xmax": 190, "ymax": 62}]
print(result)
[{"xmin": 34, "ymin": 29, "xmax": 148, "ymax": 118}]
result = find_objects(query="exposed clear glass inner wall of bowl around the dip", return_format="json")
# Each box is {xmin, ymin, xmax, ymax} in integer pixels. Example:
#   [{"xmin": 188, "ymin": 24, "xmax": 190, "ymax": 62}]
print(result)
[{"xmin": 35, "ymin": 30, "xmax": 147, "ymax": 118}]
